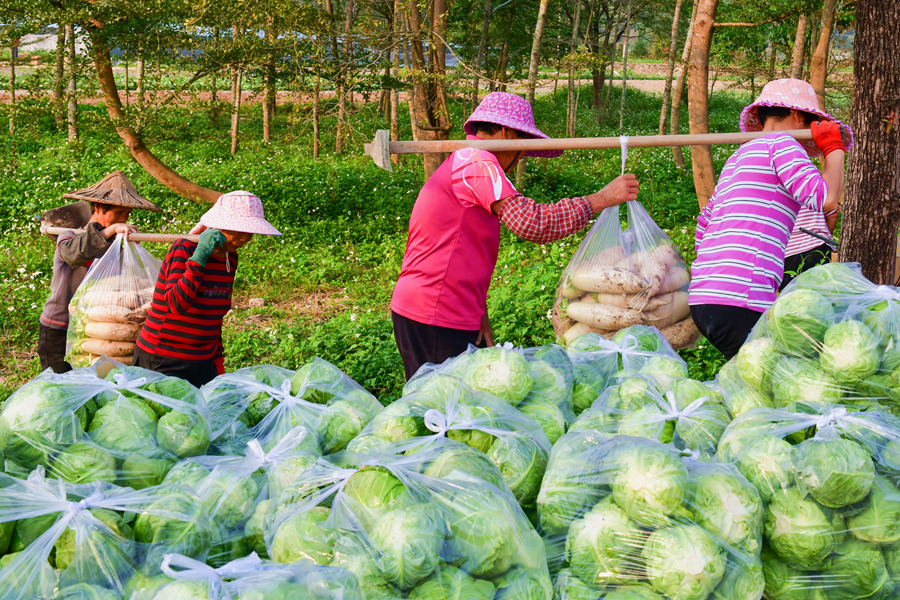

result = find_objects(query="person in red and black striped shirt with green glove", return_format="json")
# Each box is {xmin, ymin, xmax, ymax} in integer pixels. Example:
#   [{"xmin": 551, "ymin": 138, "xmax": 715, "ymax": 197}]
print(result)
[{"xmin": 134, "ymin": 191, "xmax": 281, "ymax": 387}]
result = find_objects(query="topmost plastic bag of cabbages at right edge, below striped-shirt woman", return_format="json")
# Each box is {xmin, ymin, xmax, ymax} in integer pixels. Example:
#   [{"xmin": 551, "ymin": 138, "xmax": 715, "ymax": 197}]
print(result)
[{"xmin": 720, "ymin": 263, "xmax": 900, "ymax": 413}]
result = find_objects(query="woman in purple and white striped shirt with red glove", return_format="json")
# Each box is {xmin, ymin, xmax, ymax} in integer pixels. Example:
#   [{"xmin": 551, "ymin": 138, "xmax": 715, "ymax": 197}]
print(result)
[{"xmin": 690, "ymin": 79, "xmax": 852, "ymax": 358}]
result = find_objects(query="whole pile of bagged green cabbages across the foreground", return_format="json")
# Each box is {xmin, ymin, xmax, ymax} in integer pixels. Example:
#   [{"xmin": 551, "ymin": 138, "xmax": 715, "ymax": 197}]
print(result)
[{"xmin": 0, "ymin": 265, "xmax": 900, "ymax": 600}]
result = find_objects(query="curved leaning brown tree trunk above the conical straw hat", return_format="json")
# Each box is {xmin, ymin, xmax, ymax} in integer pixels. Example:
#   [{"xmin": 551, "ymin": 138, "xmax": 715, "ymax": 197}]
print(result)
[{"xmin": 86, "ymin": 26, "xmax": 221, "ymax": 202}]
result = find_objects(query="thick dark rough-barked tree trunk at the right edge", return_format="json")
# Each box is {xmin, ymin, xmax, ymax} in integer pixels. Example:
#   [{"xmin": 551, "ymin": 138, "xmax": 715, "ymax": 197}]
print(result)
[{"xmin": 838, "ymin": 0, "xmax": 900, "ymax": 284}]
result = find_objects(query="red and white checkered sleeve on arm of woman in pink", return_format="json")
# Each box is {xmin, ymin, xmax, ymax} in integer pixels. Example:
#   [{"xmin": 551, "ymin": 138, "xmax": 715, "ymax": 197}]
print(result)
[{"xmin": 500, "ymin": 194, "xmax": 593, "ymax": 244}]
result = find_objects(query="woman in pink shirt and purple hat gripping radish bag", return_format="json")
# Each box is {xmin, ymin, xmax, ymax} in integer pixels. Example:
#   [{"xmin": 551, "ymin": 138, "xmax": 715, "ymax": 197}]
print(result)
[{"xmin": 391, "ymin": 92, "xmax": 638, "ymax": 378}]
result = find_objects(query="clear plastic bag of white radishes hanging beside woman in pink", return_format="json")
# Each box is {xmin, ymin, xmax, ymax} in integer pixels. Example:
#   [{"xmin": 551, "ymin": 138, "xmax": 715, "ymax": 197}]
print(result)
[{"xmin": 553, "ymin": 202, "xmax": 700, "ymax": 348}]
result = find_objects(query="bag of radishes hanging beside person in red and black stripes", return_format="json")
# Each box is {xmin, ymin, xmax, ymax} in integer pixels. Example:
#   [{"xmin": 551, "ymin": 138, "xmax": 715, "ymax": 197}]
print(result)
[{"xmin": 66, "ymin": 234, "xmax": 162, "ymax": 369}]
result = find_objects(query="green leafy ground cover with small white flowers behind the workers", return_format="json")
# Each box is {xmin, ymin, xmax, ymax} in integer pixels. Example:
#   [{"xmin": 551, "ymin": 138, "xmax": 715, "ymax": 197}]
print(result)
[{"xmin": 0, "ymin": 83, "xmax": 760, "ymax": 402}]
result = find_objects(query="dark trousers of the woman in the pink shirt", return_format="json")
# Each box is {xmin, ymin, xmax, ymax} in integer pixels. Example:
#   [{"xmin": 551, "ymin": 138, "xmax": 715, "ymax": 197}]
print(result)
[{"xmin": 391, "ymin": 311, "xmax": 483, "ymax": 380}]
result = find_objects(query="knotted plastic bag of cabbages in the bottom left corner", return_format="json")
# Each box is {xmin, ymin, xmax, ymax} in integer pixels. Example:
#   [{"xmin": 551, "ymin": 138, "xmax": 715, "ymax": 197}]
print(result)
[{"xmin": 0, "ymin": 468, "xmax": 210, "ymax": 600}]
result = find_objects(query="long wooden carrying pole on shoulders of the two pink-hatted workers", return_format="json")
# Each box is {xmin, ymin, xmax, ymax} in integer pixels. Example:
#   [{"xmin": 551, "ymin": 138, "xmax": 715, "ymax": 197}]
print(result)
[{"xmin": 365, "ymin": 129, "xmax": 812, "ymax": 172}]
